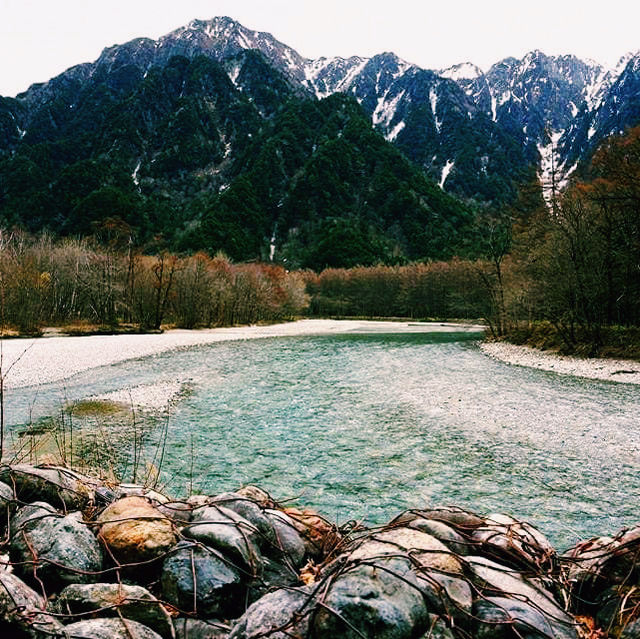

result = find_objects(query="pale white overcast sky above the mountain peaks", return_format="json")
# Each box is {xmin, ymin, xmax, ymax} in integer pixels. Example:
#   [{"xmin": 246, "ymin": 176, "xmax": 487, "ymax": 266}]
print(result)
[{"xmin": 0, "ymin": 0, "xmax": 640, "ymax": 96}]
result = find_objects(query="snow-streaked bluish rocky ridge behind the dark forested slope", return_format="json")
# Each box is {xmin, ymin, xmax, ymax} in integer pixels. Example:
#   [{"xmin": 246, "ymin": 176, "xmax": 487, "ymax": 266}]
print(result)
[{"xmin": 8, "ymin": 16, "xmax": 640, "ymax": 197}]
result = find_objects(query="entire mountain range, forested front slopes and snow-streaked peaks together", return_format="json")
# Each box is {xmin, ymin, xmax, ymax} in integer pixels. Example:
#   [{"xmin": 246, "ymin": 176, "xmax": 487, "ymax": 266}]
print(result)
[{"xmin": 0, "ymin": 17, "xmax": 640, "ymax": 267}]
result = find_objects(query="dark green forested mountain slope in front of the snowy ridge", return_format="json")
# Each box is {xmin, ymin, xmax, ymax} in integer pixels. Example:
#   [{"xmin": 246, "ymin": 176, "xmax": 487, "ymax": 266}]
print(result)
[{"xmin": 0, "ymin": 29, "xmax": 471, "ymax": 268}]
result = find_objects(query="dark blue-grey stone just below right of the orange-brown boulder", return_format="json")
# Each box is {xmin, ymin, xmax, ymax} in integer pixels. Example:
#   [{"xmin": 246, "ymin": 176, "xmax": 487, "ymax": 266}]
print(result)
[{"xmin": 160, "ymin": 541, "xmax": 246, "ymax": 619}]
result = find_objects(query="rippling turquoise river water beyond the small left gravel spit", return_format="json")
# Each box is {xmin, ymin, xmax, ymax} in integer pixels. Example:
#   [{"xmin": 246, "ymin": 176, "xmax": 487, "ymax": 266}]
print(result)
[{"xmin": 8, "ymin": 332, "xmax": 640, "ymax": 546}]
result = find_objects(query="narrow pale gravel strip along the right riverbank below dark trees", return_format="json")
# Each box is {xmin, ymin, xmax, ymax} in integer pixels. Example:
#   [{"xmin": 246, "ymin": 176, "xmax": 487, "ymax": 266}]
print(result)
[{"xmin": 480, "ymin": 342, "xmax": 640, "ymax": 384}]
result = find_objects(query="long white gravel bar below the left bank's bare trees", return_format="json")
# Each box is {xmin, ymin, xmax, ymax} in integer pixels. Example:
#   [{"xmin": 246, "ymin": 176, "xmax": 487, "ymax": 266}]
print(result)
[{"xmin": 0, "ymin": 320, "xmax": 482, "ymax": 388}]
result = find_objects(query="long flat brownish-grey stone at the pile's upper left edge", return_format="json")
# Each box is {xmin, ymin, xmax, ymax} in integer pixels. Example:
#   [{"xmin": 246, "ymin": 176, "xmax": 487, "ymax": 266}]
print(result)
[{"xmin": 0, "ymin": 464, "xmax": 98, "ymax": 510}]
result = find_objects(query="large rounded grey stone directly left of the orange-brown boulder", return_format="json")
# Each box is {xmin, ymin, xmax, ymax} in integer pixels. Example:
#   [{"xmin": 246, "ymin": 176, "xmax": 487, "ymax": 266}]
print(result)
[{"xmin": 9, "ymin": 502, "xmax": 102, "ymax": 590}]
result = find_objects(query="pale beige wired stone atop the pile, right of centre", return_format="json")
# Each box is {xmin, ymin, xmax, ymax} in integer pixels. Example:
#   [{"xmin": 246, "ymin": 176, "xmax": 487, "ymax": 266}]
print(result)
[{"xmin": 349, "ymin": 527, "xmax": 462, "ymax": 574}]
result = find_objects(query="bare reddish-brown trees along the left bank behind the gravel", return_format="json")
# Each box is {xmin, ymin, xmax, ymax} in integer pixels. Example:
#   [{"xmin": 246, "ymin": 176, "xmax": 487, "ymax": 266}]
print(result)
[{"xmin": 0, "ymin": 230, "xmax": 307, "ymax": 334}]
